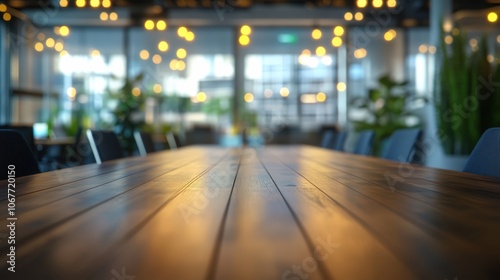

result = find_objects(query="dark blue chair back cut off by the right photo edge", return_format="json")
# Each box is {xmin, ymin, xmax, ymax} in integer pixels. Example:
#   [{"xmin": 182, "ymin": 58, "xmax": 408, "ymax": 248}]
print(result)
[{"xmin": 464, "ymin": 127, "xmax": 500, "ymax": 177}]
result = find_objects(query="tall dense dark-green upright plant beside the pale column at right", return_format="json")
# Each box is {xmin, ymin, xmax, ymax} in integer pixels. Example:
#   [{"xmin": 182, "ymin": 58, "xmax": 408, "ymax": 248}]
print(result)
[{"xmin": 434, "ymin": 28, "xmax": 500, "ymax": 155}]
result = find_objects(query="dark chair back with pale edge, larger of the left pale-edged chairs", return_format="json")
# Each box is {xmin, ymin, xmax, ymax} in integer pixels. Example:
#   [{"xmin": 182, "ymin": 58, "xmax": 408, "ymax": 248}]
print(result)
[{"xmin": 87, "ymin": 129, "xmax": 123, "ymax": 164}]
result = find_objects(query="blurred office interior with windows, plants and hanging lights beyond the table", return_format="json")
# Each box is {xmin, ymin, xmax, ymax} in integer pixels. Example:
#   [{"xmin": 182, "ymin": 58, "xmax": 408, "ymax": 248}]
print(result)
[{"xmin": 0, "ymin": 0, "xmax": 500, "ymax": 170}]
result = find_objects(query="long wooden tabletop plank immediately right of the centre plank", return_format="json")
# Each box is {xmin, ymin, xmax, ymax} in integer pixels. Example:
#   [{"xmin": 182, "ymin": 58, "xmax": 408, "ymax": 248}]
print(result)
[{"xmin": 259, "ymin": 149, "xmax": 417, "ymax": 279}]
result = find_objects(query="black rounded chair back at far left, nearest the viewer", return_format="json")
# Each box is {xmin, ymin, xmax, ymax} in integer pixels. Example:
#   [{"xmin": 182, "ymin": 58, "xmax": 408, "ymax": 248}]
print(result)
[{"xmin": 0, "ymin": 129, "xmax": 40, "ymax": 180}]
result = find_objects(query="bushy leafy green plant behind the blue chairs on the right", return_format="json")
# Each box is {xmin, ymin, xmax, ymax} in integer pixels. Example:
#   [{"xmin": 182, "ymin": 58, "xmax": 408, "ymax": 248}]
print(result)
[{"xmin": 351, "ymin": 75, "xmax": 427, "ymax": 155}]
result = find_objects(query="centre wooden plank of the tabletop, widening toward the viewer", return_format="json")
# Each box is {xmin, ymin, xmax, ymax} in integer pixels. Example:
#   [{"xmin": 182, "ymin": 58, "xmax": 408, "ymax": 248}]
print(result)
[{"xmin": 214, "ymin": 150, "xmax": 328, "ymax": 280}]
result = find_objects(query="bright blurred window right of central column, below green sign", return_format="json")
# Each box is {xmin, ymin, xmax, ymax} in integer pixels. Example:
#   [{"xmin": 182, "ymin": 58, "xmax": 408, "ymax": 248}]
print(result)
[{"xmin": 239, "ymin": 27, "xmax": 337, "ymax": 131}]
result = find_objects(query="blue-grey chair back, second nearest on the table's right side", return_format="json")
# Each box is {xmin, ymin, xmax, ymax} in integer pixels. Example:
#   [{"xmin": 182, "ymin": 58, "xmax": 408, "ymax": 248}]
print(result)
[{"xmin": 382, "ymin": 128, "xmax": 422, "ymax": 163}]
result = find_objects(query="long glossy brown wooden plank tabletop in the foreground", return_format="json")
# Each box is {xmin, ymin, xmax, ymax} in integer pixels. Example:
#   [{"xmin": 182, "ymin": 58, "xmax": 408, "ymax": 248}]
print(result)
[{"xmin": 0, "ymin": 146, "xmax": 500, "ymax": 280}]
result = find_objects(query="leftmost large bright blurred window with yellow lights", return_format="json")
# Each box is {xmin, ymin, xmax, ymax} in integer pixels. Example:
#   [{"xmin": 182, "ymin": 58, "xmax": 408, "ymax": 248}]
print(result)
[{"xmin": 12, "ymin": 27, "xmax": 126, "ymax": 128}]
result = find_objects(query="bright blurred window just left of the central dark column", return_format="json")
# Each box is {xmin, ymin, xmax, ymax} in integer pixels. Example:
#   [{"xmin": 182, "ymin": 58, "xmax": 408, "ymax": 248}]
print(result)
[{"xmin": 129, "ymin": 26, "xmax": 234, "ymax": 128}]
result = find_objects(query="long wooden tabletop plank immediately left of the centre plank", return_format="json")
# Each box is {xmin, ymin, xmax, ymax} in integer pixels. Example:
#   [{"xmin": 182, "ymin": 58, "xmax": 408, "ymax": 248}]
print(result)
[{"xmin": 85, "ymin": 150, "xmax": 239, "ymax": 280}]
